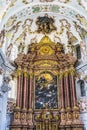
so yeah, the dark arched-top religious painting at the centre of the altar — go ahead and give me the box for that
[35,72,58,109]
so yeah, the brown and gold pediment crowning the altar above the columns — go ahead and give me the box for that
[15,36,76,69]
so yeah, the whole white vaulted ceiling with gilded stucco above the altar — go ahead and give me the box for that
[0,0,87,60]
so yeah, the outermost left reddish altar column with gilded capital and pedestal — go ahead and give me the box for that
[11,67,22,130]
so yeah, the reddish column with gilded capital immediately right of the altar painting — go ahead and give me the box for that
[59,71,66,130]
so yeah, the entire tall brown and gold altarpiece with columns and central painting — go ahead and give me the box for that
[11,36,83,130]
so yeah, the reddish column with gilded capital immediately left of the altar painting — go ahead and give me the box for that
[27,69,34,130]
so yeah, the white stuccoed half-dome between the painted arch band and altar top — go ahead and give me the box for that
[5,14,85,57]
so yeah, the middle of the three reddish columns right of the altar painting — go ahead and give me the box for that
[64,69,72,127]
